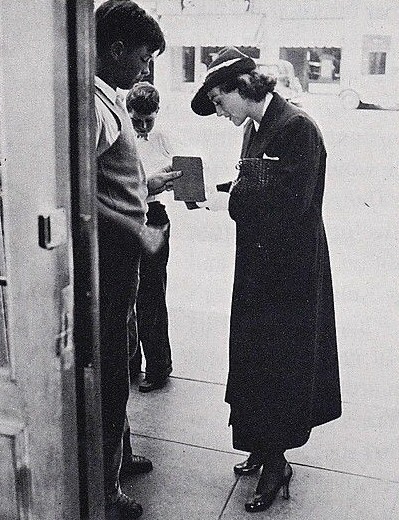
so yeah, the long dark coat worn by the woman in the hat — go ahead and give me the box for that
[226,93,341,451]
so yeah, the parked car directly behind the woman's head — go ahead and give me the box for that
[258,60,303,106]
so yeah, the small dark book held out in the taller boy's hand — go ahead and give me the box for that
[172,155,206,202]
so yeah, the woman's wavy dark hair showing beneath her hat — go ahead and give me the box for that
[218,70,277,101]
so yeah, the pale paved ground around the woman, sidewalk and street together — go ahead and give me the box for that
[126,93,399,520]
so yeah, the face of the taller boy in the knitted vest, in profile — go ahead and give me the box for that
[115,45,156,90]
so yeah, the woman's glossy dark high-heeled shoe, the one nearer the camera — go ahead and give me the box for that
[245,456,293,513]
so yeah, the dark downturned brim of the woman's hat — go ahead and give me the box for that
[191,58,256,116]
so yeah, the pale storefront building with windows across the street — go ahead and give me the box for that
[135,0,399,106]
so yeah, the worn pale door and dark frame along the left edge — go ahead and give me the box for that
[0,0,104,520]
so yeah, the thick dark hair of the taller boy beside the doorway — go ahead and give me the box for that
[96,0,165,55]
